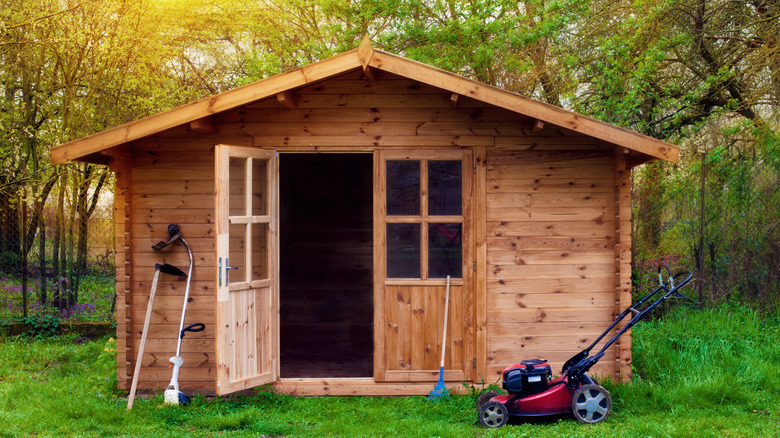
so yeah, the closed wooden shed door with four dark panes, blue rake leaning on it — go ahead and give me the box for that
[374,149,475,382]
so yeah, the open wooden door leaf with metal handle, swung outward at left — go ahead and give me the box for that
[215,145,279,395]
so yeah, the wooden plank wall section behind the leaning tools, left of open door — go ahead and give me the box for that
[120,138,251,393]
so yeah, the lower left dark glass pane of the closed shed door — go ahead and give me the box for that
[387,224,420,278]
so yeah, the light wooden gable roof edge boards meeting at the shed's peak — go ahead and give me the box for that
[51,37,679,164]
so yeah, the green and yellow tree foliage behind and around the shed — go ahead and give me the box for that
[0,0,780,314]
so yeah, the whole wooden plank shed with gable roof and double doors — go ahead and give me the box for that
[51,40,678,395]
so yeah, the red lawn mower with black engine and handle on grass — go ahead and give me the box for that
[477,268,693,427]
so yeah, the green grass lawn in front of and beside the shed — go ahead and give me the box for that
[0,308,780,437]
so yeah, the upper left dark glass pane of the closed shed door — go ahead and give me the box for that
[387,161,420,216]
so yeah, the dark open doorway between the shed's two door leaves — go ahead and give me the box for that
[279,154,374,378]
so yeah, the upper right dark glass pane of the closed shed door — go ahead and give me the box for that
[428,161,463,216]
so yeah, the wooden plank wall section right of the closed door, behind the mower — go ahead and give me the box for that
[485,145,630,382]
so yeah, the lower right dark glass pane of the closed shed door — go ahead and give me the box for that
[428,224,463,278]
